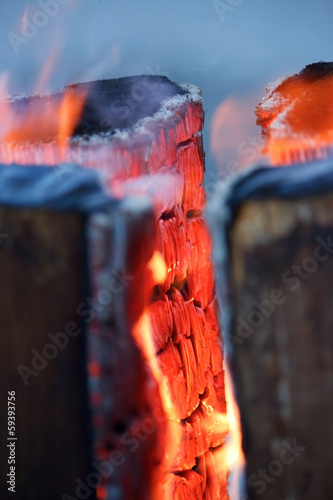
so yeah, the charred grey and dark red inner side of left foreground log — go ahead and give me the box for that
[87,198,164,499]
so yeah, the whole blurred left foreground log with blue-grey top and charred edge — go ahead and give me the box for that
[0,166,162,499]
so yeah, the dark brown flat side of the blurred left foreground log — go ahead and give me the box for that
[0,207,93,500]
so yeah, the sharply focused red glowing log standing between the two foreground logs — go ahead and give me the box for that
[0,76,227,500]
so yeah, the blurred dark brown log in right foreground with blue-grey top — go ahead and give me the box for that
[211,161,333,500]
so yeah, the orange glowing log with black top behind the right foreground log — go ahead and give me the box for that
[256,62,333,165]
